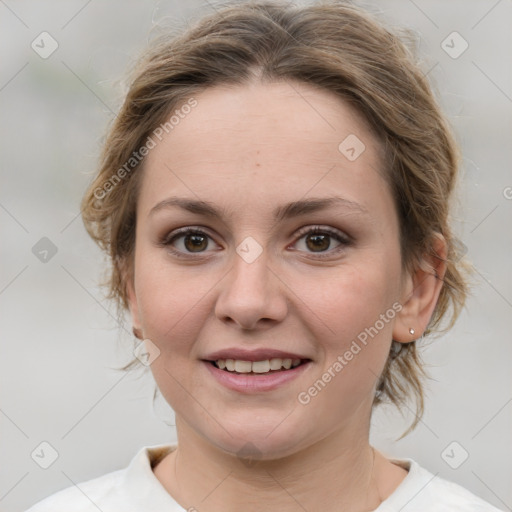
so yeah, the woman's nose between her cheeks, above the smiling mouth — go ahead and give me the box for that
[215,251,288,330]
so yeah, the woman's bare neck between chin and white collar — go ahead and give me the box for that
[155,418,388,512]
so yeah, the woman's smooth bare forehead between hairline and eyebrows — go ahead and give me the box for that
[140,82,383,218]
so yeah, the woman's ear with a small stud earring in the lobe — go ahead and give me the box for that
[393,233,447,343]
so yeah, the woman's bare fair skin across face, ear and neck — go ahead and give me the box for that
[127,82,445,512]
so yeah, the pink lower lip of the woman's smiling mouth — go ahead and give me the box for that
[203,361,311,393]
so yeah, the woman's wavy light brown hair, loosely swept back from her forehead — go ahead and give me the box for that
[82,1,466,431]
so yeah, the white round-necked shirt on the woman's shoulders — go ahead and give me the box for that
[27,445,500,512]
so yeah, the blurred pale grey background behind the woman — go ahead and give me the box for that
[0,0,512,511]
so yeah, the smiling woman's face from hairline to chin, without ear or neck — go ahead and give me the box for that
[129,82,412,459]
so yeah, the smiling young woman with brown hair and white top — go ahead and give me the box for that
[26,2,497,512]
